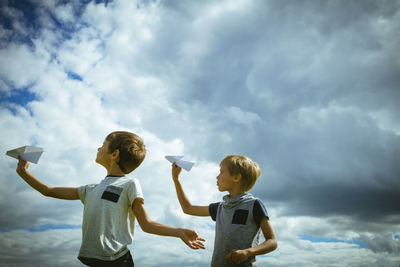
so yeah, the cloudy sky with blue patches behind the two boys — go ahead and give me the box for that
[0,0,400,267]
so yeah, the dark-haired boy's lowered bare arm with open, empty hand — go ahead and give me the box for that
[132,198,205,249]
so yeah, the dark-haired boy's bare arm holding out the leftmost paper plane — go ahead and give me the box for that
[16,157,79,200]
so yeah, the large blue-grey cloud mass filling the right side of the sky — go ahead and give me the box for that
[136,1,400,224]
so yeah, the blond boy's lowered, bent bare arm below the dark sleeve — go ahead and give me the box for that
[226,217,278,264]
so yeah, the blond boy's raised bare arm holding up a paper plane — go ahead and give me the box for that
[172,163,210,216]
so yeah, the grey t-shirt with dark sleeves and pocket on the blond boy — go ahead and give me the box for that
[209,193,268,267]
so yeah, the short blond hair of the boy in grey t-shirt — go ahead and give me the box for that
[220,155,261,192]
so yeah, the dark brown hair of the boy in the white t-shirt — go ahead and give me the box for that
[106,131,146,174]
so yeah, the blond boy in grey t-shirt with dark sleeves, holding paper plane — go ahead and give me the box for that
[172,155,278,267]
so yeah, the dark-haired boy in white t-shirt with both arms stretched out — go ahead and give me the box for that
[17,131,204,267]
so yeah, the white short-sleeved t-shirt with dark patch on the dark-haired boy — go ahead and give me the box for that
[78,176,143,261]
